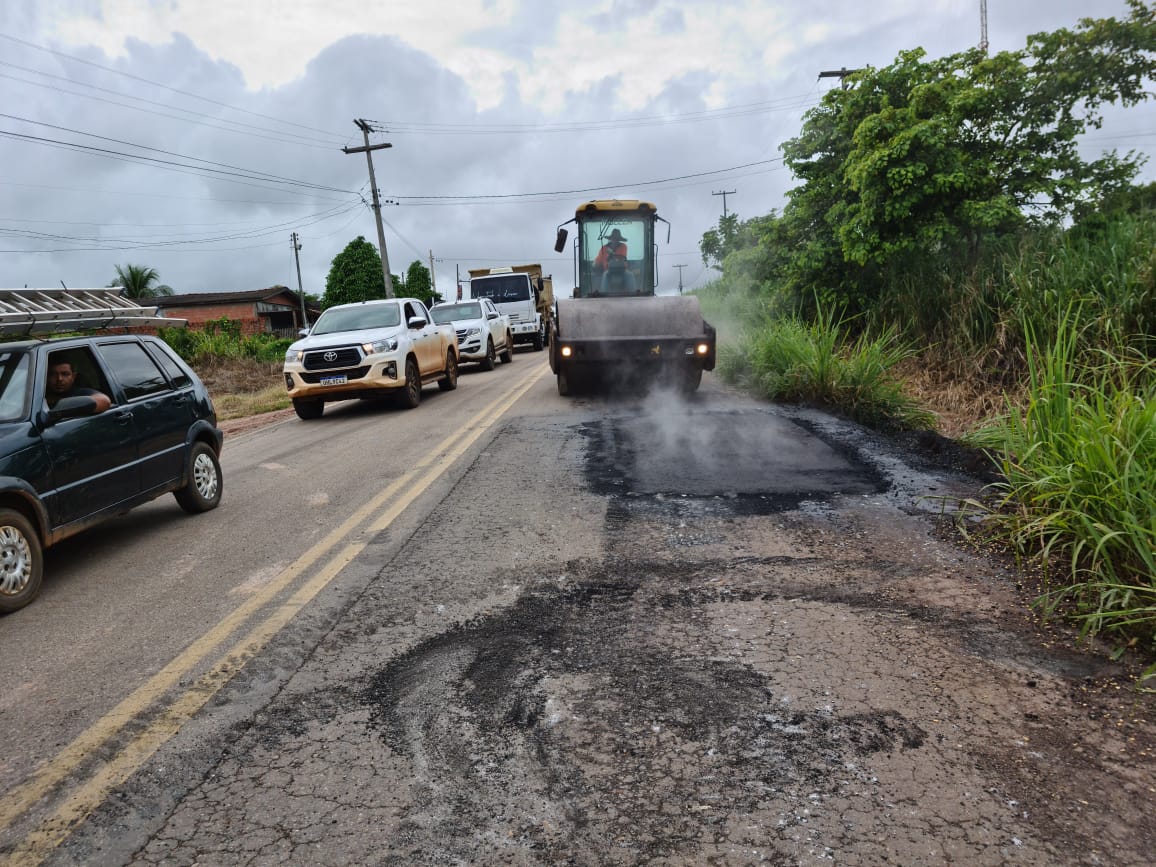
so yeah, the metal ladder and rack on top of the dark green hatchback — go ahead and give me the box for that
[0,289,188,336]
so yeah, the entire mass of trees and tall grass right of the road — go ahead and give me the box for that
[699,0,1156,676]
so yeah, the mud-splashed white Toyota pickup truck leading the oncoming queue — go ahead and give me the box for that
[284,298,458,418]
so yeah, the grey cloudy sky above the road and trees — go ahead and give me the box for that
[0,0,1156,295]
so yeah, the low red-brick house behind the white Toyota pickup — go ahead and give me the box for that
[151,286,321,338]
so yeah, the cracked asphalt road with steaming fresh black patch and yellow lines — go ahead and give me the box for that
[0,351,1156,865]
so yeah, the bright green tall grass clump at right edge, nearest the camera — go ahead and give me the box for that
[973,316,1156,673]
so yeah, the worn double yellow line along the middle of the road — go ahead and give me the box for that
[0,365,549,867]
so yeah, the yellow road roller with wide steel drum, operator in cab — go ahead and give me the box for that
[549,199,716,395]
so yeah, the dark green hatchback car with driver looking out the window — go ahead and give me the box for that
[0,334,223,613]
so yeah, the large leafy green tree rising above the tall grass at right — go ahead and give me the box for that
[784,0,1156,309]
